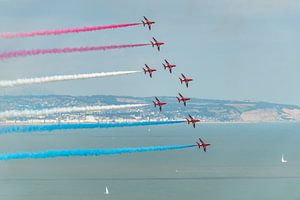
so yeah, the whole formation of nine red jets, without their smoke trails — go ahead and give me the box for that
[142,16,210,152]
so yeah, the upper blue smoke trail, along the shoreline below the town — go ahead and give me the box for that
[0,120,184,134]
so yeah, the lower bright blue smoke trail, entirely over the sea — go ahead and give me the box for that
[0,145,197,160]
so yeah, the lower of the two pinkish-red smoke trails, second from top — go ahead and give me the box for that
[0,44,150,59]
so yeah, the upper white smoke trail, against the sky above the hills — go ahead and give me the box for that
[0,71,140,87]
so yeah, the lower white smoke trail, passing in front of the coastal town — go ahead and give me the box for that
[0,104,148,119]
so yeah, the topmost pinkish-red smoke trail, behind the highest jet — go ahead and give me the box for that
[0,23,141,38]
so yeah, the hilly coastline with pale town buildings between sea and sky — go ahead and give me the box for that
[0,95,300,125]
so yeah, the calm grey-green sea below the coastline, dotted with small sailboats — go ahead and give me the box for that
[0,123,300,200]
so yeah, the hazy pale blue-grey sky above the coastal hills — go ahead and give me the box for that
[0,0,300,105]
